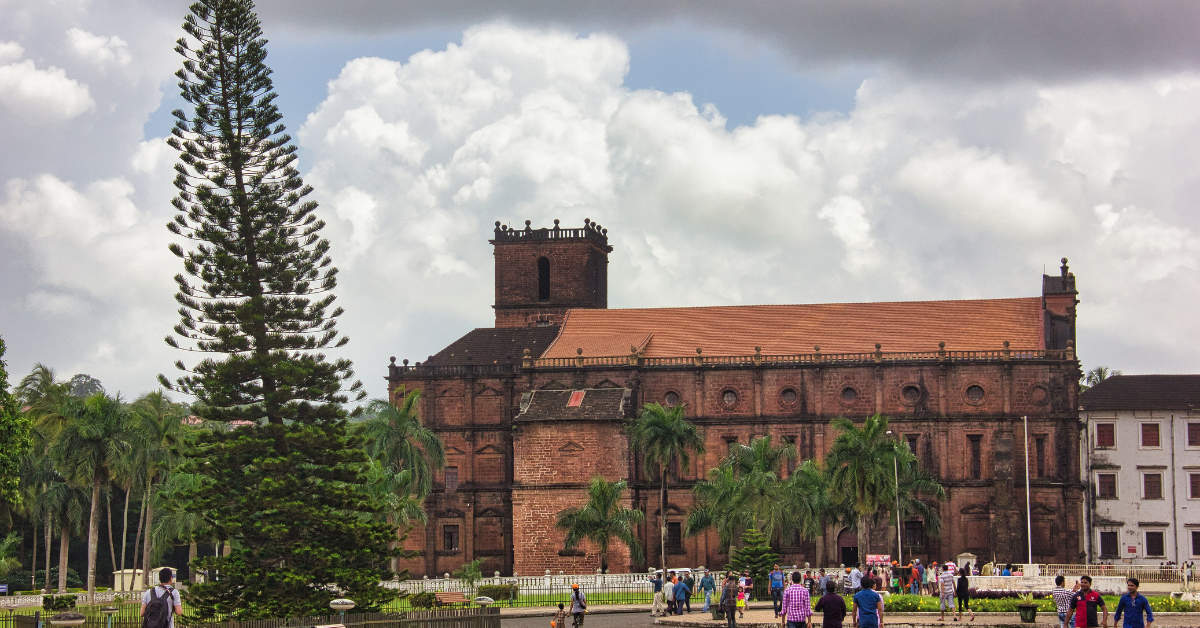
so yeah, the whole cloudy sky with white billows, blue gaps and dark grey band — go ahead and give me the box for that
[0,0,1200,396]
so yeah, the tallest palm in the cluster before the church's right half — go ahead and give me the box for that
[826,414,911,554]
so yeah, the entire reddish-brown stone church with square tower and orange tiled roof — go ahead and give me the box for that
[388,220,1084,578]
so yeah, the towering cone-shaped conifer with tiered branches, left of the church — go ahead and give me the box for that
[160,0,395,620]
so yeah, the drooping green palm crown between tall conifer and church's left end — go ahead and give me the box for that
[358,389,446,500]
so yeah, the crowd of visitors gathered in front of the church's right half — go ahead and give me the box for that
[633,560,1154,628]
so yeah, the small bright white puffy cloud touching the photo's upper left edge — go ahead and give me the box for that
[0,59,96,125]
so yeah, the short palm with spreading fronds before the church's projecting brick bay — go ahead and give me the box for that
[554,476,646,570]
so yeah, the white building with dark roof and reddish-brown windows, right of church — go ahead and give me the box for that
[1079,375,1200,564]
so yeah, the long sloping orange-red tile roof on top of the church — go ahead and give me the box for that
[541,297,1044,358]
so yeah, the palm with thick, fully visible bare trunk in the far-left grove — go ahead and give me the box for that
[50,393,130,597]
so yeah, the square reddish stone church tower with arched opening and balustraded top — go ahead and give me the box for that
[491,219,612,327]
